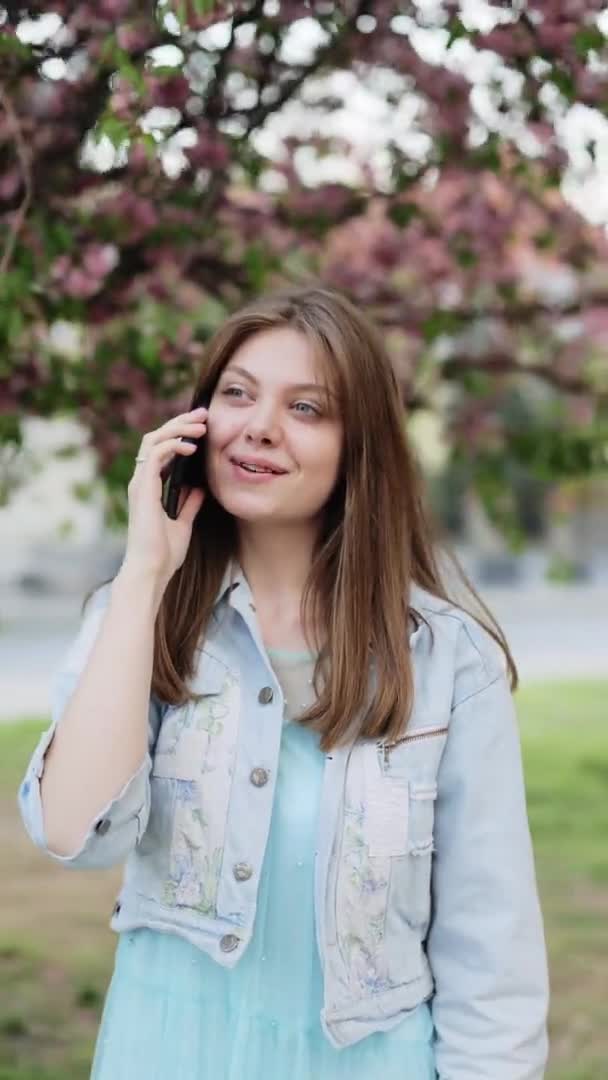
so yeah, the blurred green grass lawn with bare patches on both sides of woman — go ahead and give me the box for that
[0,681,608,1080]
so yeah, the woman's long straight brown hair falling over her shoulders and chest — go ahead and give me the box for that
[92,285,518,752]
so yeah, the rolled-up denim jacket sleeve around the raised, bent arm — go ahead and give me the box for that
[17,584,164,868]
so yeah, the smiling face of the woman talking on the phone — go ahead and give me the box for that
[206,327,342,524]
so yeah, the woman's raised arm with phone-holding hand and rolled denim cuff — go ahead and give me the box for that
[18,409,206,866]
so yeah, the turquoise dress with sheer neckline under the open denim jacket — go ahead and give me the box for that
[91,649,436,1080]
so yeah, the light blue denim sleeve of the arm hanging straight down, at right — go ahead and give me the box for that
[427,632,549,1080]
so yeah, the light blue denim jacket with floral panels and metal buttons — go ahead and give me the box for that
[19,565,549,1080]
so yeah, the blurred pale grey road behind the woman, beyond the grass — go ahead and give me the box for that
[0,581,608,720]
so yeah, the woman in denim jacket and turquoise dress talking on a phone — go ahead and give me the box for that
[19,287,548,1080]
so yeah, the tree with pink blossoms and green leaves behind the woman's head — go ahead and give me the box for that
[0,0,608,529]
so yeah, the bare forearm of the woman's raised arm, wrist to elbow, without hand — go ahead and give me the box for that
[41,567,162,855]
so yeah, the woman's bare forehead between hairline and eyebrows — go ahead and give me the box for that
[225,326,329,387]
